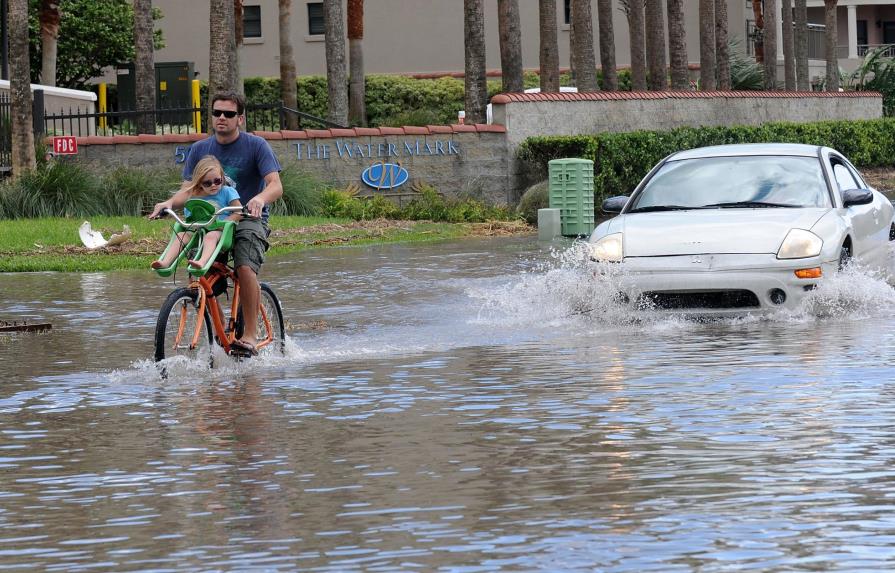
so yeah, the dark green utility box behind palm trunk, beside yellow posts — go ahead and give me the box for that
[118,62,195,123]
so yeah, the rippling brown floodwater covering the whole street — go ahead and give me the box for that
[0,238,895,572]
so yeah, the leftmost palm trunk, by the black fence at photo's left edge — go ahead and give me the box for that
[7,0,37,177]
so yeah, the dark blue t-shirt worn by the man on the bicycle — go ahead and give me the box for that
[183,131,282,221]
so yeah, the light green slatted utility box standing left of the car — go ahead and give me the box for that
[547,158,594,237]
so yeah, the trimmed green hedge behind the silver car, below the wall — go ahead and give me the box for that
[517,118,895,202]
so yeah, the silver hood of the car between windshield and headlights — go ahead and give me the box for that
[610,208,829,257]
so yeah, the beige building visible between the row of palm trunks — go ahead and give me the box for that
[153,0,751,79]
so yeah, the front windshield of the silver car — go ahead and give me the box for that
[630,156,830,211]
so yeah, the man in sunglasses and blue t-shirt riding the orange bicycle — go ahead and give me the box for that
[149,92,283,354]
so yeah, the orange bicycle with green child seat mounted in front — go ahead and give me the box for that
[154,199,286,366]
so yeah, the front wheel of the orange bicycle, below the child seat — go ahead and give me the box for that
[155,288,212,362]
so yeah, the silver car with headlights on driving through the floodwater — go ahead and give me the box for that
[587,144,895,314]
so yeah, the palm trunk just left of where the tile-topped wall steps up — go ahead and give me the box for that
[463,0,488,123]
